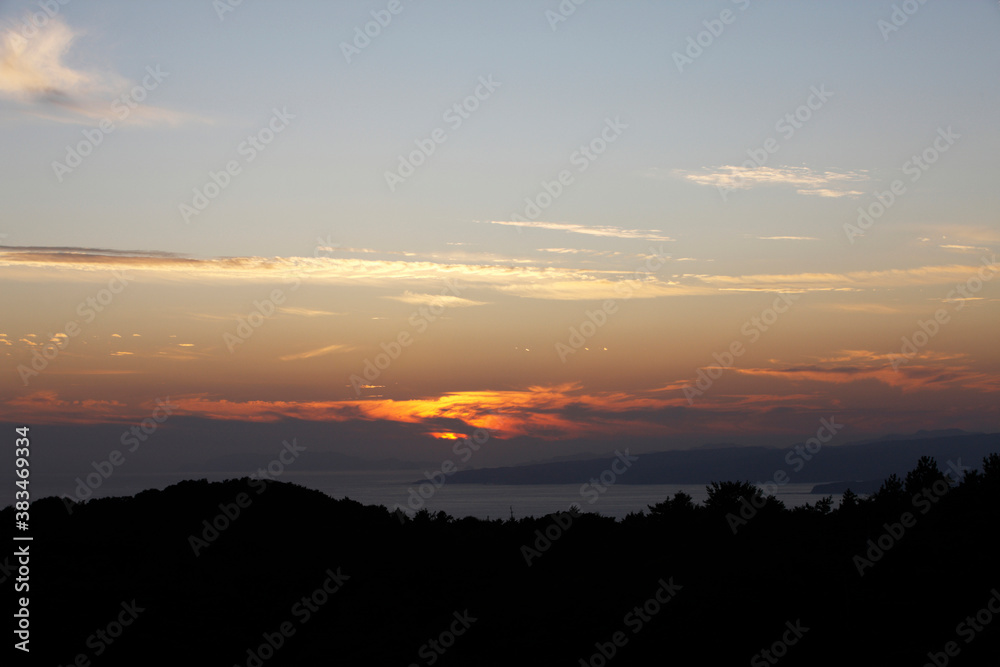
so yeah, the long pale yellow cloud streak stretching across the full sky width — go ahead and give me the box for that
[0,249,996,302]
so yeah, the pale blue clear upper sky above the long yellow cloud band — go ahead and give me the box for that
[0,2,1000,265]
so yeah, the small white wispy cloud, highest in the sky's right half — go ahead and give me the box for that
[672,165,868,197]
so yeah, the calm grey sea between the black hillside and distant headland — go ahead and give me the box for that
[29,470,840,519]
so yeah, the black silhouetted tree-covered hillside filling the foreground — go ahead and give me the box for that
[7,454,1000,667]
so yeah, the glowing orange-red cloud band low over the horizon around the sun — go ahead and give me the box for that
[5,358,1000,430]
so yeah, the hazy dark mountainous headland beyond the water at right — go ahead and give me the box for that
[449,433,1000,484]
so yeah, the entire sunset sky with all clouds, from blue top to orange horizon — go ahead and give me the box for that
[0,0,1000,465]
